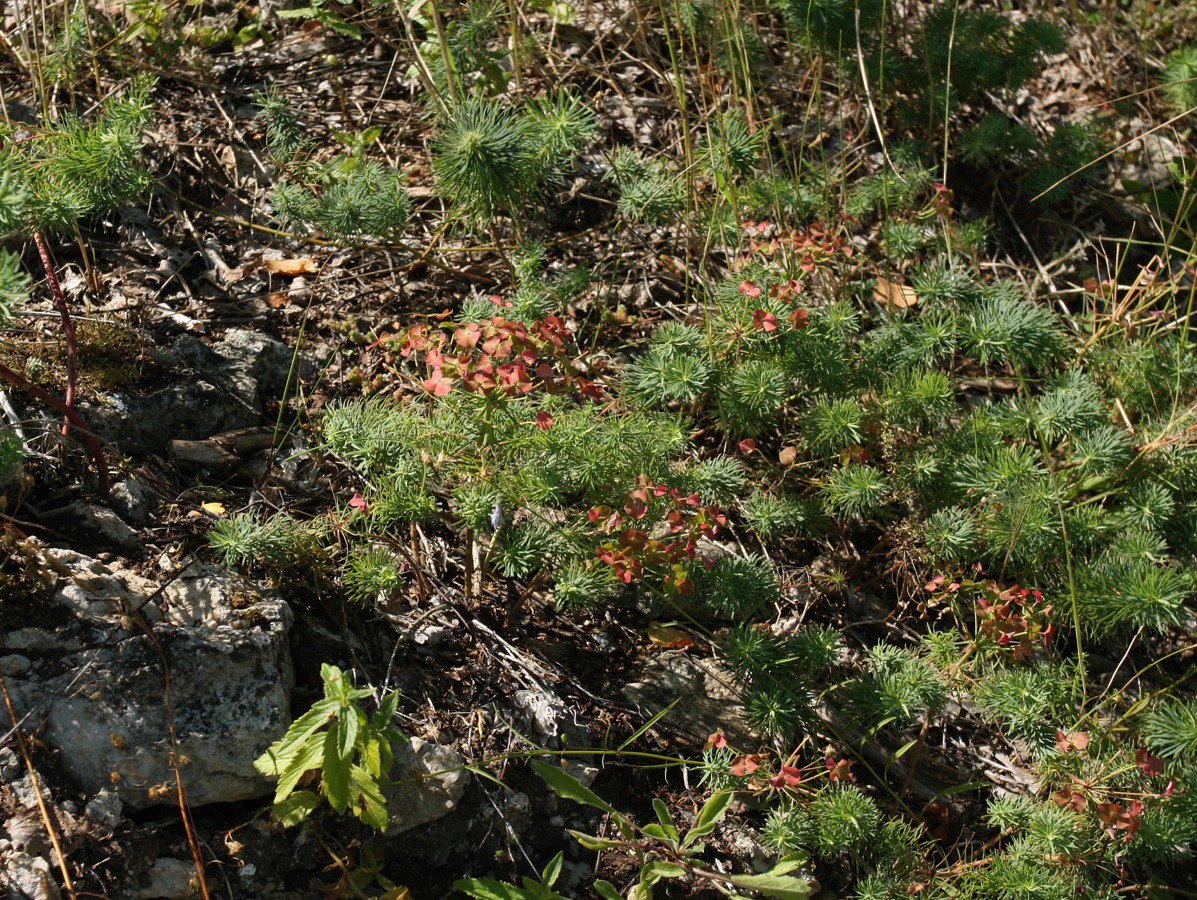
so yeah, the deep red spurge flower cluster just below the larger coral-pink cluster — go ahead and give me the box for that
[589,475,728,594]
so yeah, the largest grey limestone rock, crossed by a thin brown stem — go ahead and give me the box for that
[10,551,293,809]
